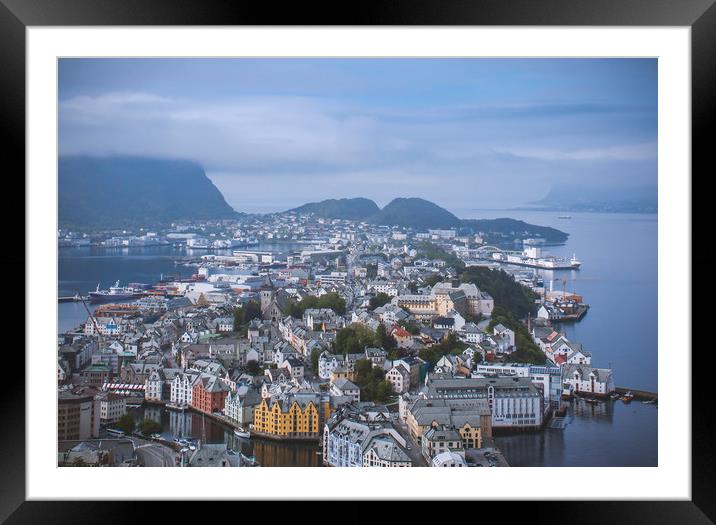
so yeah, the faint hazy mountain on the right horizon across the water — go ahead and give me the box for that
[530,184,659,213]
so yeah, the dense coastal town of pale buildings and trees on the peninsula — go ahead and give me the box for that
[57,213,634,467]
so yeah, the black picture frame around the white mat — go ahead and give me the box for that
[0,0,716,524]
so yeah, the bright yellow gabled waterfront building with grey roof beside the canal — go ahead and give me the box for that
[251,392,326,440]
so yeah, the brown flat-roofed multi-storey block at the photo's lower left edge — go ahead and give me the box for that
[57,389,100,441]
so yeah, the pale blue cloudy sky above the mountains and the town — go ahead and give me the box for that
[59,58,657,212]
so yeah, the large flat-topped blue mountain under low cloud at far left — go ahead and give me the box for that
[58,156,239,228]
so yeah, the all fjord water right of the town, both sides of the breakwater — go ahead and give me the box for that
[457,210,656,467]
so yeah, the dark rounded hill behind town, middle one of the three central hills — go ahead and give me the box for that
[368,197,462,228]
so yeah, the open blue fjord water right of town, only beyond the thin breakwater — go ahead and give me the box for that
[457,210,656,392]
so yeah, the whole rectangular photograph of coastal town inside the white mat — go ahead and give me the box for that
[56,56,660,466]
